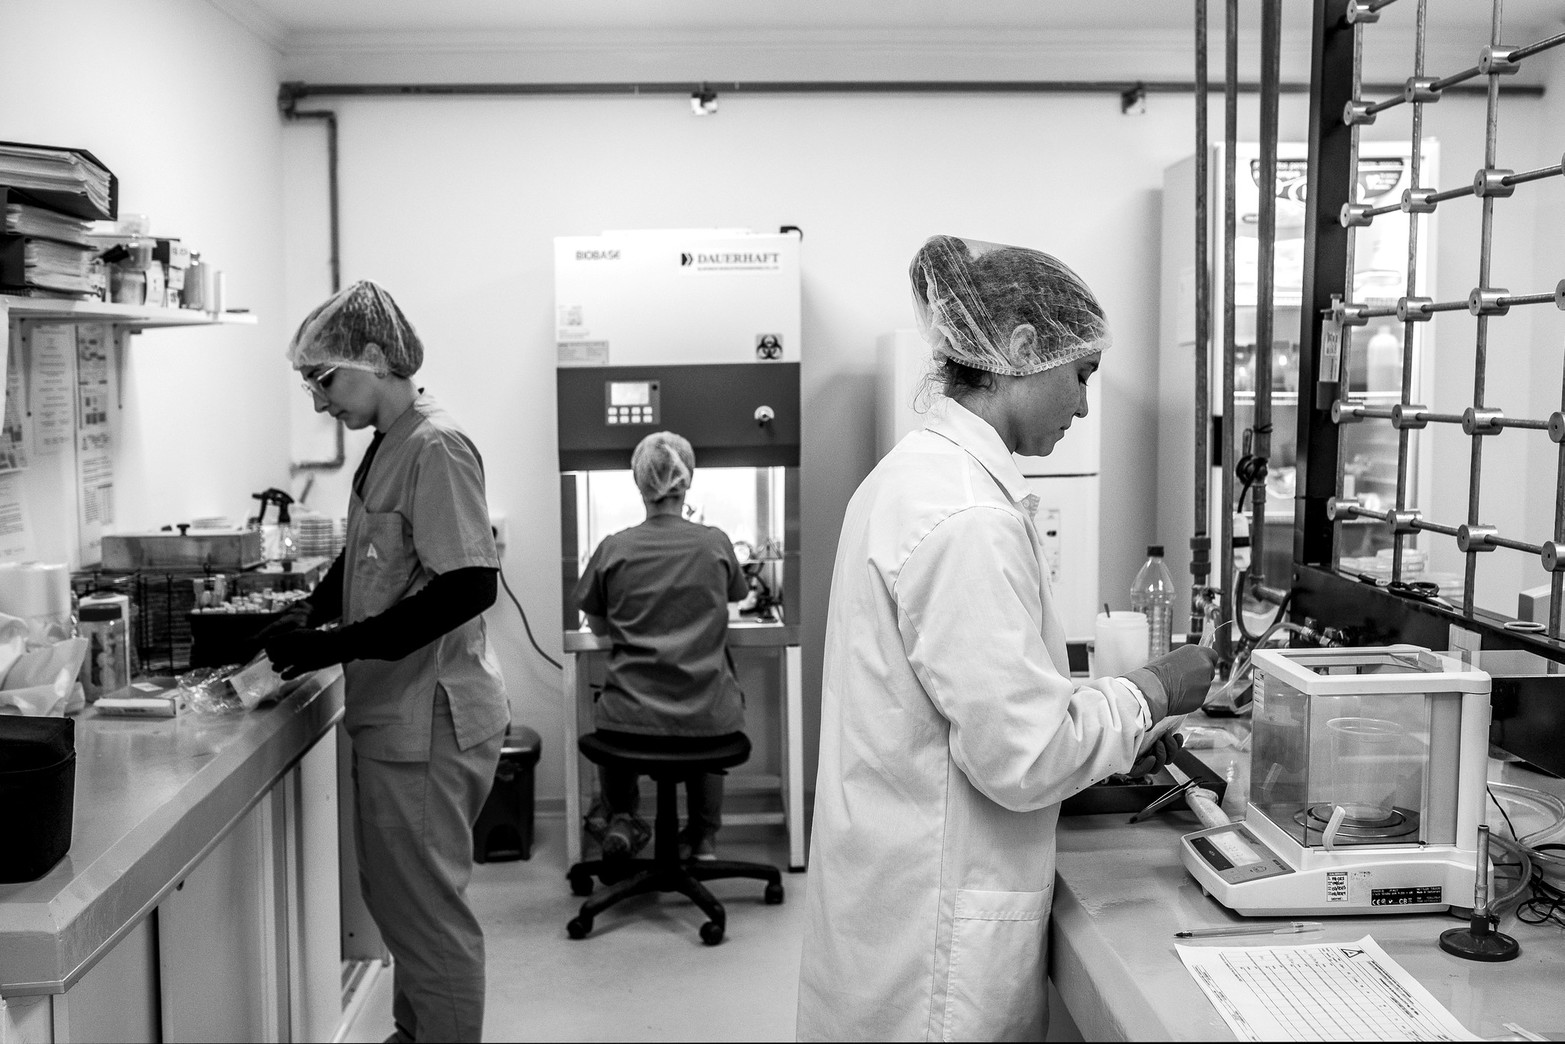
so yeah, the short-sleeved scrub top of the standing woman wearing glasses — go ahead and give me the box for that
[343,393,510,761]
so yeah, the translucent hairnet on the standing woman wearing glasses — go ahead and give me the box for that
[288,279,424,377]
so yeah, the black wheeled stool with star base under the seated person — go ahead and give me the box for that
[565,733,783,945]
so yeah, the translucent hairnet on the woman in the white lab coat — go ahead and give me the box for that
[908,236,1110,377]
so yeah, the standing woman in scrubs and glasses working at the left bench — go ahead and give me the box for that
[266,282,510,1041]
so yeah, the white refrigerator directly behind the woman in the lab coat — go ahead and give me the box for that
[875,330,1101,639]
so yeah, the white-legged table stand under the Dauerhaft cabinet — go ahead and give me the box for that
[562,620,804,870]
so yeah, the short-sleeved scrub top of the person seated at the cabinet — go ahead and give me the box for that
[576,515,750,736]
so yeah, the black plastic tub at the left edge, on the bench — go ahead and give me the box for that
[0,715,77,884]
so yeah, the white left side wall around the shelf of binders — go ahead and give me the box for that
[0,0,290,540]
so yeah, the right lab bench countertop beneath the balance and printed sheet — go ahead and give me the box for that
[1049,720,1565,1041]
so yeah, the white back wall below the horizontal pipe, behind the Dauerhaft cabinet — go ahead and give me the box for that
[275,94,1191,795]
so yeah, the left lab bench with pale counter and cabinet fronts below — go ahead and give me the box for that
[0,668,353,1042]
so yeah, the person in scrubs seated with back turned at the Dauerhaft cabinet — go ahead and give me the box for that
[576,432,748,859]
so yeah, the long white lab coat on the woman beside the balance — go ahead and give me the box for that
[798,402,1150,1041]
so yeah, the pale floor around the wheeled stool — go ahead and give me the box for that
[344,819,804,1041]
